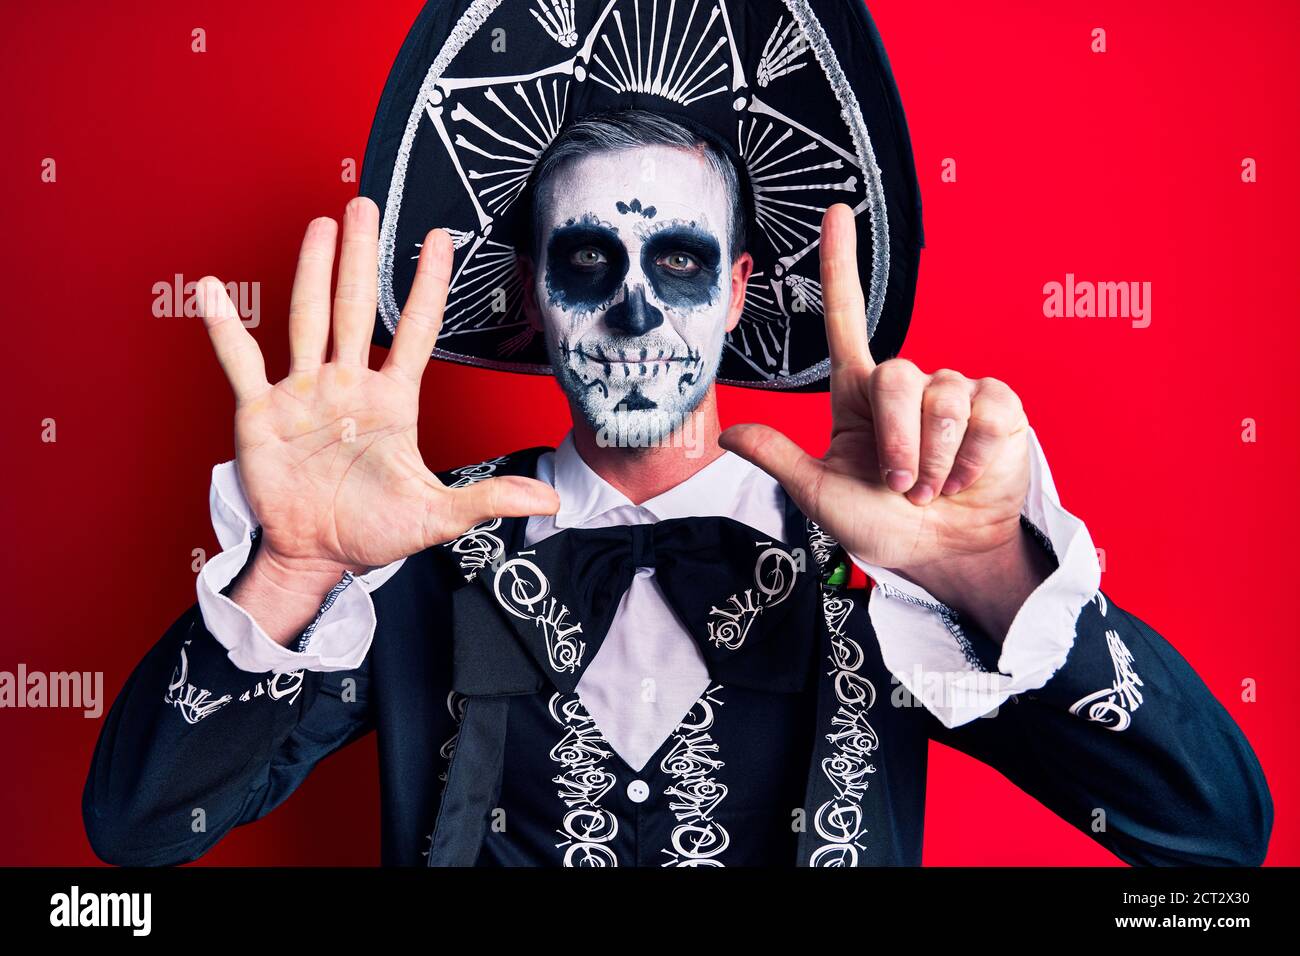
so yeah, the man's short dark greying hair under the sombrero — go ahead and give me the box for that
[528,108,753,261]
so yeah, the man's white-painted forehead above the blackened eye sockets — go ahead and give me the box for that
[537,146,729,234]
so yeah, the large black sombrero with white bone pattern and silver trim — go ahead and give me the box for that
[361,0,924,392]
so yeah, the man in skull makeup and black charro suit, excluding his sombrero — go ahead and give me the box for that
[85,0,1273,865]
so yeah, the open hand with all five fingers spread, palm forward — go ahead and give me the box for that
[199,198,559,643]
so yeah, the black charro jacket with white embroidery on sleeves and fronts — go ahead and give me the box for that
[83,447,1273,866]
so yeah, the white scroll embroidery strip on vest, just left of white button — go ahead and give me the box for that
[550,693,619,866]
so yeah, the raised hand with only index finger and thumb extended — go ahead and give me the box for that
[720,204,1043,634]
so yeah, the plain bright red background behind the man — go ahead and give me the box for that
[0,0,1300,865]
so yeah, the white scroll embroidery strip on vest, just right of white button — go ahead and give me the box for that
[659,684,731,866]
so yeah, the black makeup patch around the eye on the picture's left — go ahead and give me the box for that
[546,216,628,312]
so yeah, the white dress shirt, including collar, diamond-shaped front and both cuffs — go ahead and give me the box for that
[198,429,1101,769]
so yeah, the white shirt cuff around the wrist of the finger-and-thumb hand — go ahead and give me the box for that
[849,428,1101,727]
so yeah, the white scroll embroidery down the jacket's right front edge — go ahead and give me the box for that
[807,520,880,866]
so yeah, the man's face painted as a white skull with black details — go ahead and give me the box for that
[534,146,732,434]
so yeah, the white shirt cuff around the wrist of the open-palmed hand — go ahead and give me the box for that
[196,460,406,674]
